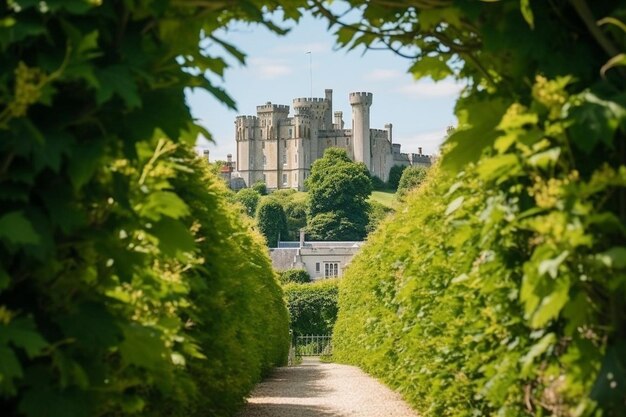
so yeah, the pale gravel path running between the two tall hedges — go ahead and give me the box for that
[238,358,417,417]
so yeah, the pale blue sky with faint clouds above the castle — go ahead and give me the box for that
[187,9,460,160]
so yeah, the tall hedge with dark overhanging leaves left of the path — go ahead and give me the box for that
[0,1,289,417]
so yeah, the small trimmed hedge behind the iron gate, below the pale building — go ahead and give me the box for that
[283,279,339,335]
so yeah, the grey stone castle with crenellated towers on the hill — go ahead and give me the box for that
[235,89,431,190]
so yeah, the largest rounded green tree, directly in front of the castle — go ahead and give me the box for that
[306,148,372,240]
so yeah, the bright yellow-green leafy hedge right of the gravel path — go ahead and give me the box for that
[333,158,626,417]
